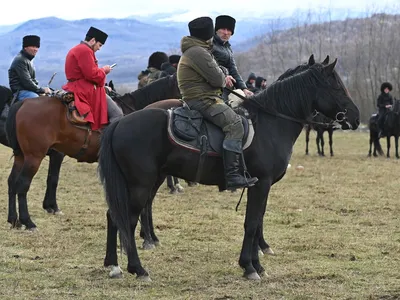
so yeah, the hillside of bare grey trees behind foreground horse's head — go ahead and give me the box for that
[233,12,400,122]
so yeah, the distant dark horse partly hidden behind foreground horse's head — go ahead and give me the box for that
[305,112,336,156]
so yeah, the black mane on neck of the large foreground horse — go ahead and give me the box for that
[244,63,322,118]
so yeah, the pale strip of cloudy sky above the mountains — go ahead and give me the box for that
[0,0,400,25]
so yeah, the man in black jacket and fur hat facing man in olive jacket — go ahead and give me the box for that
[212,15,253,101]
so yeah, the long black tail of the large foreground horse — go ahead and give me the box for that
[98,122,134,253]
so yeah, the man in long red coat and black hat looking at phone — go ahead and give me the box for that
[62,27,122,130]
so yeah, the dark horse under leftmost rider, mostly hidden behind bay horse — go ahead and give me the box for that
[0,86,64,214]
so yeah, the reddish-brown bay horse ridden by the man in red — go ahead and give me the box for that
[5,76,180,230]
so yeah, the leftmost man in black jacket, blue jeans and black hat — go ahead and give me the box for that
[8,35,50,100]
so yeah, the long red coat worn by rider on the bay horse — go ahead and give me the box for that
[62,42,108,130]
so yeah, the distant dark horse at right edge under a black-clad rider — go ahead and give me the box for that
[368,99,400,159]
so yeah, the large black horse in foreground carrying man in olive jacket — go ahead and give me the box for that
[99,60,360,279]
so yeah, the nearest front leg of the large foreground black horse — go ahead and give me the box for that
[239,180,271,280]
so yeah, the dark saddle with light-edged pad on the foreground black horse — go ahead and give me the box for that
[168,105,254,156]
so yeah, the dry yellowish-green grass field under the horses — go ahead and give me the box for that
[0,132,400,300]
